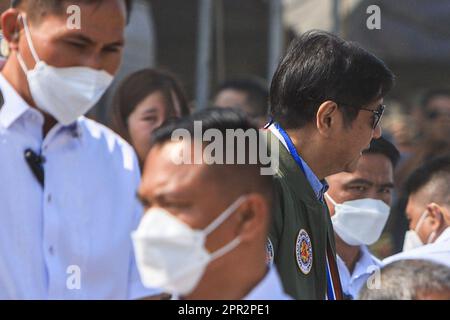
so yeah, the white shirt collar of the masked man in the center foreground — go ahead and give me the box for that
[243,266,292,300]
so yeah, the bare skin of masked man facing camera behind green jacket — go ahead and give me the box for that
[327,154,394,272]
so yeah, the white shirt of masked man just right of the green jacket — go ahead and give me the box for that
[336,245,383,299]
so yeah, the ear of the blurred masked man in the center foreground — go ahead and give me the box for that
[237,193,270,243]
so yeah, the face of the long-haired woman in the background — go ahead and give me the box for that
[127,91,181,163]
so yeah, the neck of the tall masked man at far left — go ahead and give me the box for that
[2,52,57,137]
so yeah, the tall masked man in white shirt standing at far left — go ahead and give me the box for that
[0,0,159,299]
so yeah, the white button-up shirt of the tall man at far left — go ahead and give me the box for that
[0,74,156,299]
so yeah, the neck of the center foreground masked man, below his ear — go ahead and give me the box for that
[183,248,267,300]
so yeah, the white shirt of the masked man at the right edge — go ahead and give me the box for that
[383,227,450,267]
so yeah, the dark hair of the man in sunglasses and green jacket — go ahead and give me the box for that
[270,31,394,129]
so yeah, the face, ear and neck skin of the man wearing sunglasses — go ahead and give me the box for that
[287,99,383,179]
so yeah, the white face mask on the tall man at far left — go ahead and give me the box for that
[17,16,114,125]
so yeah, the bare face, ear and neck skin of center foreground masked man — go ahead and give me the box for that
[138,142,269,299]
